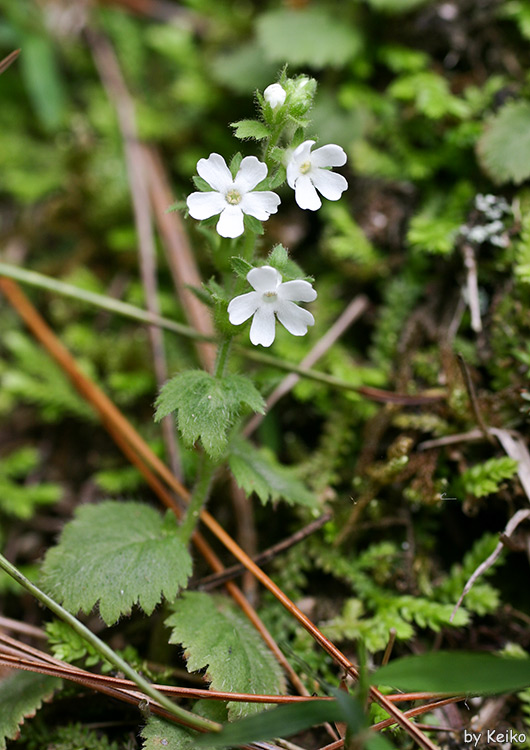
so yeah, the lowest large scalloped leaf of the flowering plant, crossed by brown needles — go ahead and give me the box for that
[166,591,285,719]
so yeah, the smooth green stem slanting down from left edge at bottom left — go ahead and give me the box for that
[0,555,221,732]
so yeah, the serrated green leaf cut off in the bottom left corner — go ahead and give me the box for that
[0,672,62,750]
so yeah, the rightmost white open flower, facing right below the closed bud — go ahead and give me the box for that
[287,141,348,211]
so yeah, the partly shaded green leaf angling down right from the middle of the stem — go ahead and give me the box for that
[228,440,318,508]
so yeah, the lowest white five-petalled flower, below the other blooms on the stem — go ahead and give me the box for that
[228,266,317,346]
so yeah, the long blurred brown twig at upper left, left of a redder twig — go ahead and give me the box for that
[85,28,182,478]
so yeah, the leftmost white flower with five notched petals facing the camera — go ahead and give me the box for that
[186,154,280,237]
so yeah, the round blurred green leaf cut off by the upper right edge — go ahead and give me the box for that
[477,101,530,184]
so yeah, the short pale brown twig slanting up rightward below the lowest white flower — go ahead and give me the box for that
[243,295,369,437]
